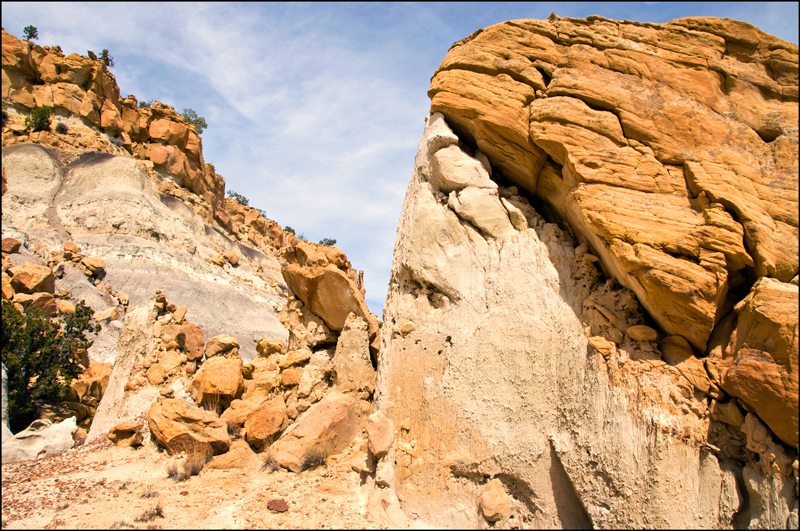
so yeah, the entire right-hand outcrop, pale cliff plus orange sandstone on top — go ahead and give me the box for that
[376,15,798,527]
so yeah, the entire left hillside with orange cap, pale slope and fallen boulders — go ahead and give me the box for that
[2,26,380,477]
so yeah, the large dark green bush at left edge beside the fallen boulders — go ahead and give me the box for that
[0,300,100,433]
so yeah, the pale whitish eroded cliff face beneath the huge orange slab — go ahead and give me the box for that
[376,113,796,528]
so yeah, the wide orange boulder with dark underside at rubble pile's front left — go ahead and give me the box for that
[147,399,231,455]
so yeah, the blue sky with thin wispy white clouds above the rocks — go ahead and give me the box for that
[2,2,798,317]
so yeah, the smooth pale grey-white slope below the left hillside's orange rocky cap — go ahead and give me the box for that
[3,144,288,362]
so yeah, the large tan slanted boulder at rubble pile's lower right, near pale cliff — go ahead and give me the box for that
[271,391,358,472]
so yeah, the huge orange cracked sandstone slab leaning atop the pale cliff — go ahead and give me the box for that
[429,17,798,351]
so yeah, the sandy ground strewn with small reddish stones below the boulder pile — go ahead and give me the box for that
[2,441,382,529]
